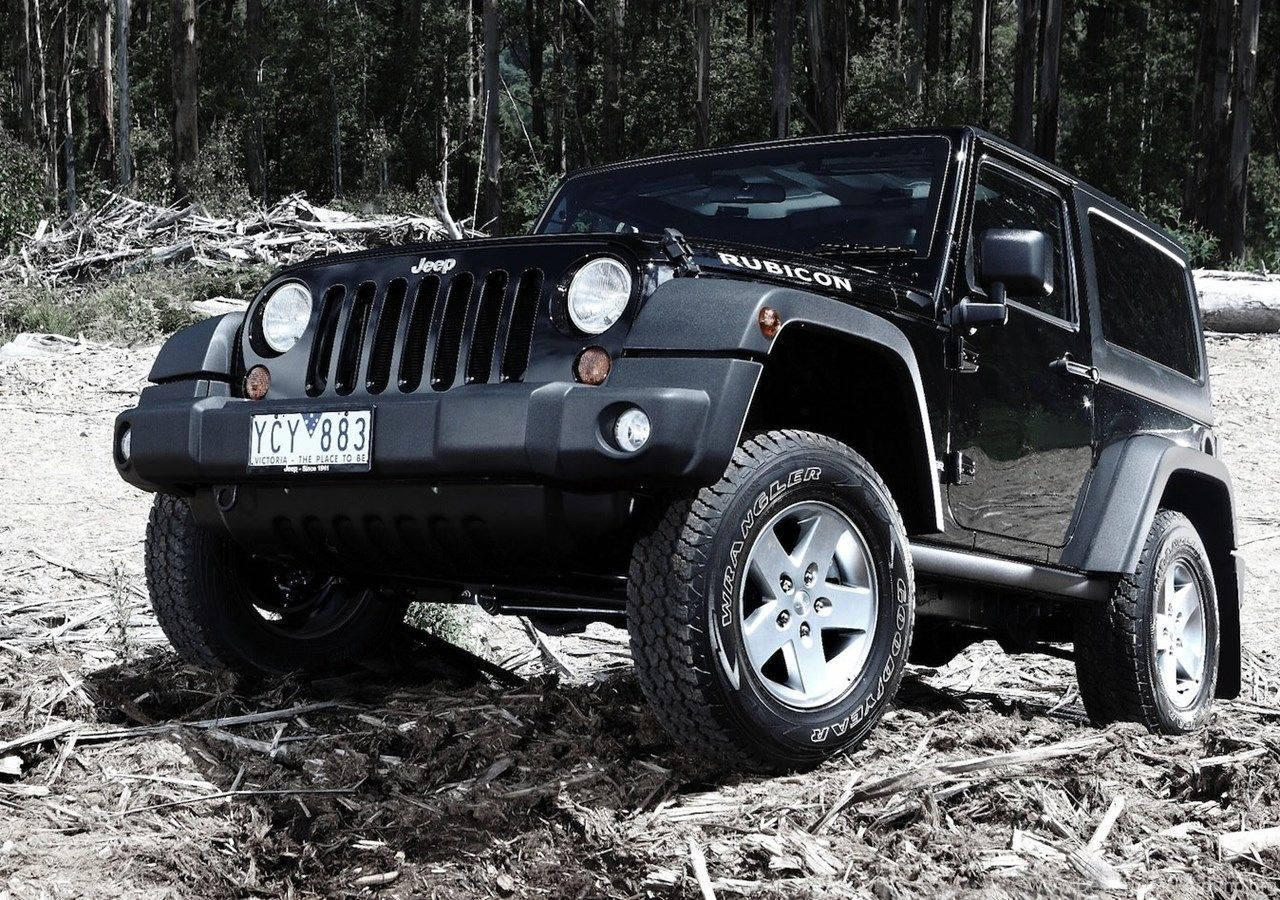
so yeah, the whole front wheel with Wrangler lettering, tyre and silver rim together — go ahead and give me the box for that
[627,431,915,771]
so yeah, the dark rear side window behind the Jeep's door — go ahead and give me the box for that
[1089,214,1199,378]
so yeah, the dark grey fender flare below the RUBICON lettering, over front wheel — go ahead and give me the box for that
[625,278,945,531]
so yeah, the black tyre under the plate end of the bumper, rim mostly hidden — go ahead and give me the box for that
[146,494,404,675]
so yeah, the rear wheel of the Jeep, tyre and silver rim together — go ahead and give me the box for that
[1075,510,1219,734]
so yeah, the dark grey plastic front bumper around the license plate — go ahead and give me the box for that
[115,357,762,493]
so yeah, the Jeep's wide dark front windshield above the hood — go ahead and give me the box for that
[538,137,948,264]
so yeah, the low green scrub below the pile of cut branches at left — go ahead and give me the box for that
[0,265,270,344]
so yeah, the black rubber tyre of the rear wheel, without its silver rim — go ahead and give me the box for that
[1075,510,1220,734]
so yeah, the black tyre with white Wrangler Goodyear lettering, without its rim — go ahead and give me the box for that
[627,430,915,772]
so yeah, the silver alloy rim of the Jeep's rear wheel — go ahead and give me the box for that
[1155,559,1206,709]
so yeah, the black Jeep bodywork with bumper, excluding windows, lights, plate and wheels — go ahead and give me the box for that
[116,128,1239,694]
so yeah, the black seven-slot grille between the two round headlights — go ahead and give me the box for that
[307,269,543,397]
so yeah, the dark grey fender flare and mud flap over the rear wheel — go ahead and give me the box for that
[1060,434,1243,698]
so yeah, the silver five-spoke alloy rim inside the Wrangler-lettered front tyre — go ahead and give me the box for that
[739,501,879,709]
